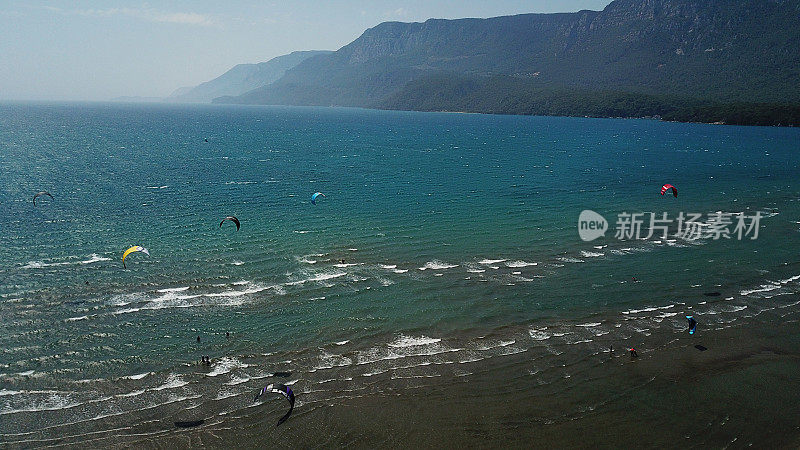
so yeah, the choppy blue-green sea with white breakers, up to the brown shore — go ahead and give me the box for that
[0,104,800,441]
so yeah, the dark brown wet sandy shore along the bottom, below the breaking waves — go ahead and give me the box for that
[31,314,800,448]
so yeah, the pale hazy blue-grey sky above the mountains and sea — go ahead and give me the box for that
[0,0,610,100]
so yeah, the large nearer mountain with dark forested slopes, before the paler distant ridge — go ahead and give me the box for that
[206,0,800,125]
